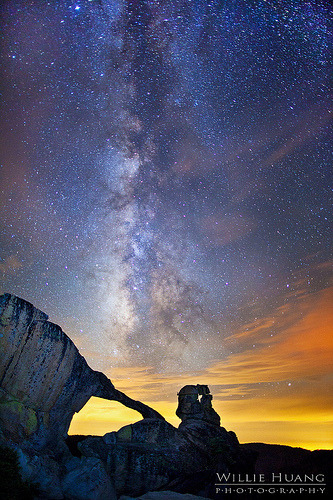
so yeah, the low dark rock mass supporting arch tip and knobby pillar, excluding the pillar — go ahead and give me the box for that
[78,419,239,498]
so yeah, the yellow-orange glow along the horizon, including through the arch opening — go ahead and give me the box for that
[70,288,333,450]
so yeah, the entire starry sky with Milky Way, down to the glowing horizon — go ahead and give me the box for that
[0,0,333,449]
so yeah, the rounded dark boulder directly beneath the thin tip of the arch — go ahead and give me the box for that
[78,419,184,495]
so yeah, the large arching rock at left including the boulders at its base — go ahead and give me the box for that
[0,294,164,500]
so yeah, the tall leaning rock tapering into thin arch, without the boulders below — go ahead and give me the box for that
[0,294,163,450]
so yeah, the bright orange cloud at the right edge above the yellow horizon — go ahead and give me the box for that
[208,288,333,383]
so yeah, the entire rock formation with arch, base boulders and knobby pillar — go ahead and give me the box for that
[0,294,249,500]
